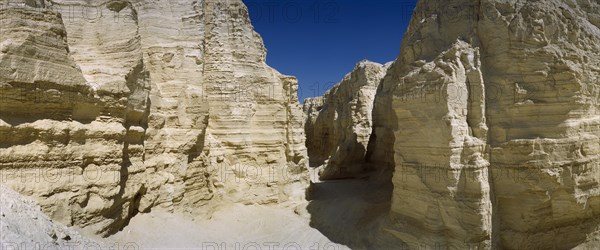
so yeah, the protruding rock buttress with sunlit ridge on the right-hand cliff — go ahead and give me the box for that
[384,42,492,247]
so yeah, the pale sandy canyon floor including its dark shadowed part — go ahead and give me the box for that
[96,168,391,250]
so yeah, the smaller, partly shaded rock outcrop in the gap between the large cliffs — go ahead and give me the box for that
[303,61,389,179]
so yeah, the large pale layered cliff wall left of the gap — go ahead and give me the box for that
[0,0,306,234]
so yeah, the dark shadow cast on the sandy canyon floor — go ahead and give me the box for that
[307,165,393,249]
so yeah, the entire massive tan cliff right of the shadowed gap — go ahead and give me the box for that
[372,0,600,249]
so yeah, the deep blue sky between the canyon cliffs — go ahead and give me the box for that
[243,0,416,102]
